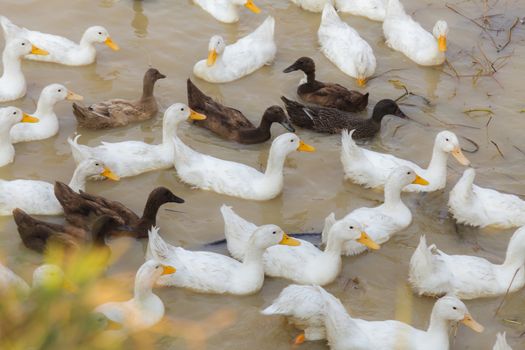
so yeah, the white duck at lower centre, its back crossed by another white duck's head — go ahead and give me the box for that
[221,205,379,285]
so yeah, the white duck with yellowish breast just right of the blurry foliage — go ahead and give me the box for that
[95,260,176,332]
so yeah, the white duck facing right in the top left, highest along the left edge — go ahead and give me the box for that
[0,16,120,66]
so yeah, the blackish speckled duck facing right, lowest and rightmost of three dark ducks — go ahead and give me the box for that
[281,96,407,139]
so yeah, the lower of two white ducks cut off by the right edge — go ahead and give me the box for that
[408,231,525,299]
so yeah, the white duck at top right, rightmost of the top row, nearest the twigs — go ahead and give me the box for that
[383,0,448,66]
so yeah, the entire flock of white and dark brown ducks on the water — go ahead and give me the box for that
[0,0,525,350]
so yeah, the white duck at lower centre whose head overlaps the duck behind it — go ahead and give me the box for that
[147,225,300,295]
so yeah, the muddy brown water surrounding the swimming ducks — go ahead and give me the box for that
[0,0,525,350]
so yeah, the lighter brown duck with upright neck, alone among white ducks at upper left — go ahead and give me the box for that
[73,68,166,130]
